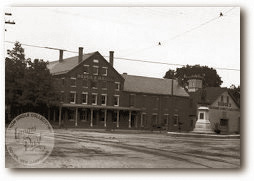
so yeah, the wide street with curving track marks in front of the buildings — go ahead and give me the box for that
[6,130,240,168]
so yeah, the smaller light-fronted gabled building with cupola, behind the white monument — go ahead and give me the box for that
[189,76,240,134]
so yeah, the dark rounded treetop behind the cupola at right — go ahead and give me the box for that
[164,65,223,87]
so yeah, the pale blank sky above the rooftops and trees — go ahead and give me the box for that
[5,7,240,87]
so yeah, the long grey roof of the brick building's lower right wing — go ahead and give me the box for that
[122,74,189,97]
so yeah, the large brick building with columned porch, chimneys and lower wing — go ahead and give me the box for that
[48,47,192,131]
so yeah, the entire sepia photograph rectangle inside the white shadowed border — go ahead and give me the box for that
[3,6,241,169]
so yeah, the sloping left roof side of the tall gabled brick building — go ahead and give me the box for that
[48,52,96,75]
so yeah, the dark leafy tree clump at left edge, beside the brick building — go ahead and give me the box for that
[5,42,59,119]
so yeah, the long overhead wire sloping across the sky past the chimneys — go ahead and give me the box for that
[5,41,240,71]
